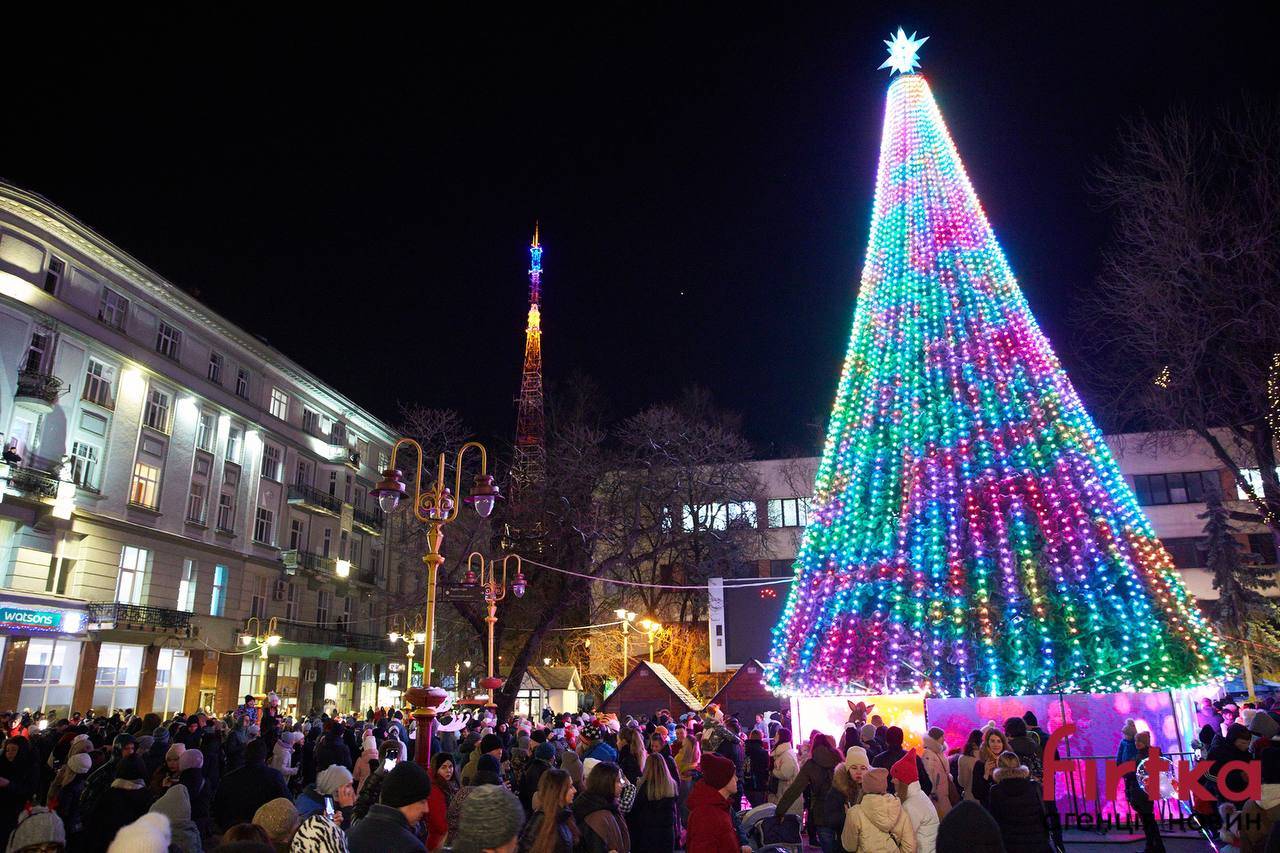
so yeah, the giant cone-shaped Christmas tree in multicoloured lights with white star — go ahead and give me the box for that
[769,29,1224,695]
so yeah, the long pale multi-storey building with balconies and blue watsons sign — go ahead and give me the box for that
[0,183,404,715]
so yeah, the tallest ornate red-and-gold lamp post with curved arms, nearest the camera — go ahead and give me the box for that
[370,438,499,772]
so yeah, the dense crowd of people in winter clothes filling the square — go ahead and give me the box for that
[0,697,1280,853]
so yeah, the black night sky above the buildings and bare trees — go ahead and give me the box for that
[0,3,1276,455]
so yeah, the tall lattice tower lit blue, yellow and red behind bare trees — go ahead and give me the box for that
[511,224,547,508]
